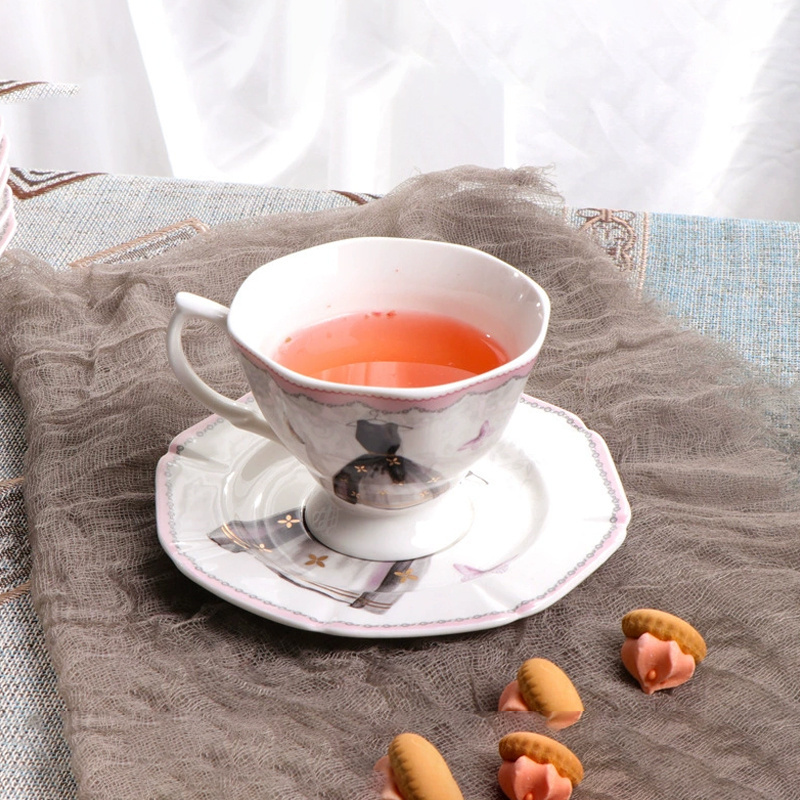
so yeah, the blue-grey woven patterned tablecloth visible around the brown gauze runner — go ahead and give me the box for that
[0,167,800,800]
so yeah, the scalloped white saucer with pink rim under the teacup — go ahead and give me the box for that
[156,395,630,638]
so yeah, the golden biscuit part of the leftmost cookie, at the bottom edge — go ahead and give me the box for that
[389,733,464,800]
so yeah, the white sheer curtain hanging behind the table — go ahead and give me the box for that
[0,0,800,220]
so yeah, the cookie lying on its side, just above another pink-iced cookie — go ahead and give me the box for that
[497,658,583,731]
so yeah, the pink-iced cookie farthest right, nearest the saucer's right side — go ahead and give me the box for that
[620,608,706,694]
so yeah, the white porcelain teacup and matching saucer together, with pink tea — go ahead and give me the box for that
[156,237,630,637]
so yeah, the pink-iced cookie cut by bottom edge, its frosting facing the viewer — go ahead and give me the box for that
[497,731,583,800]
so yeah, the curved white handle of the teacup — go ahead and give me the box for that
[167,292,279,442]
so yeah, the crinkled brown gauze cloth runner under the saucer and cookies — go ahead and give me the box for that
[0,168,800,800]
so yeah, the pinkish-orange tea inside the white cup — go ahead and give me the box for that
[274,309,509,388]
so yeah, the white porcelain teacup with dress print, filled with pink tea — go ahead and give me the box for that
[167,238,550,561]
